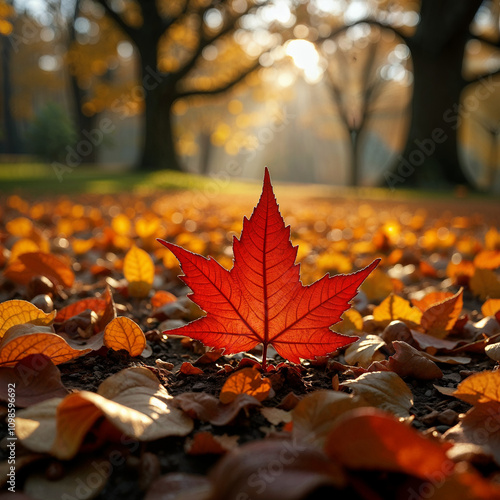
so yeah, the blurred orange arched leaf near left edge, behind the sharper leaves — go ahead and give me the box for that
[4,252,75,288]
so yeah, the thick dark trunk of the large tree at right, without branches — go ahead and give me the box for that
[389,0,481,187]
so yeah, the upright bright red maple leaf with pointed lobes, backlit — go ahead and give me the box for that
[158,168,380,369]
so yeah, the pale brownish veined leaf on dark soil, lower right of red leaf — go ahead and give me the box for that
[342,372,413,418]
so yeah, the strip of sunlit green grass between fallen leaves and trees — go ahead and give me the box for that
[0,163,497,202]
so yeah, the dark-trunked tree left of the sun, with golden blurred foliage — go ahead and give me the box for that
[85,0,284,170]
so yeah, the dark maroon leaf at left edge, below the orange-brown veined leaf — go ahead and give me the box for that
[0,354,68,408]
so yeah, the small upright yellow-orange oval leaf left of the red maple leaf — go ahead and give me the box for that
[123,245,155,298]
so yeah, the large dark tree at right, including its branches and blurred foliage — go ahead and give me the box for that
[312,0,499,187]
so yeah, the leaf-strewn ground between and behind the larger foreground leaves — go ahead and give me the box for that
[0,180,500,499]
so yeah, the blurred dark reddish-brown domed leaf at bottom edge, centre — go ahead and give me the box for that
[209,439,346,500]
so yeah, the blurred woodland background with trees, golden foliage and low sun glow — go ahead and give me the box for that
[0,0,500,193]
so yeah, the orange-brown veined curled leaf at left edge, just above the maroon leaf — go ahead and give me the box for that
[0,323,91,366]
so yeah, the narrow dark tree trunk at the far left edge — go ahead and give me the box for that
[0,36,20,154]
